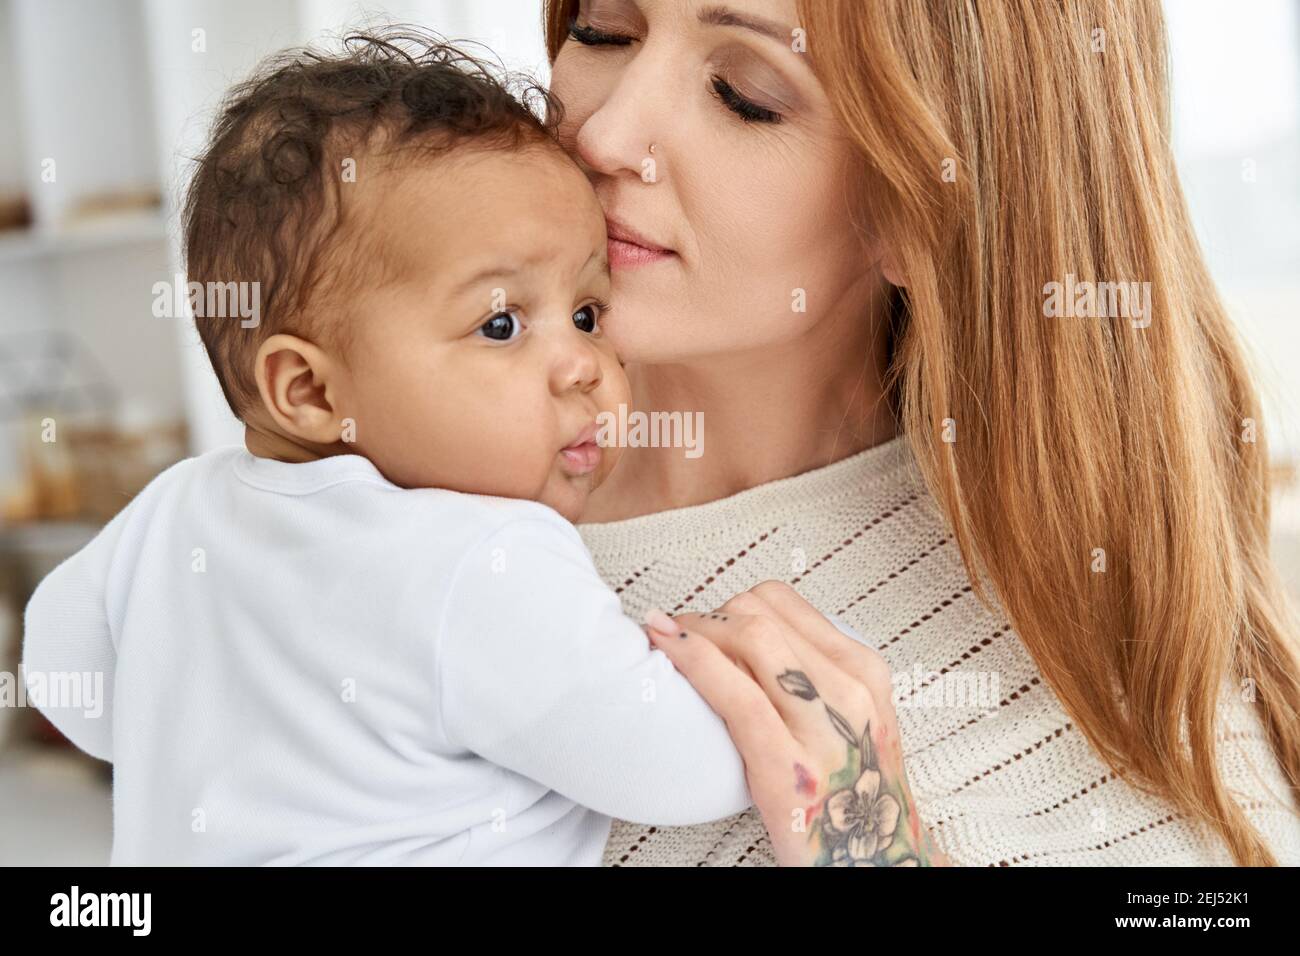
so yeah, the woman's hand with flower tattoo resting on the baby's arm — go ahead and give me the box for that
[646,581,950,866]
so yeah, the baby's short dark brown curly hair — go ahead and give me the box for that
[182,27,560,419]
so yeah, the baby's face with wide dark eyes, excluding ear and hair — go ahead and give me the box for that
[341,150,628,520]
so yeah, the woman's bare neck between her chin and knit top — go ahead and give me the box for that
[580,303,897,523]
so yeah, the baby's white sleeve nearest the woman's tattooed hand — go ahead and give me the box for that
[434,515,751,826]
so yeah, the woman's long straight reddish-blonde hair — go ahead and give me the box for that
[546,0,1300,865]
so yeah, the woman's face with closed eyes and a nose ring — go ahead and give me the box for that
[551,0,880,363]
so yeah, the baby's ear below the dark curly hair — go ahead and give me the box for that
[255,333,342,445]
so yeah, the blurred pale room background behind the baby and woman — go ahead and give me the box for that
[0,0,1300,865]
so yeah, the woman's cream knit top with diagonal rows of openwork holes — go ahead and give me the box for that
[579,438,1300,866]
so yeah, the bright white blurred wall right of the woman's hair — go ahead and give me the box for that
[1165,0,1300,460]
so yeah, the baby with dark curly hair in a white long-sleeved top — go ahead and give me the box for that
[25,31,750,865]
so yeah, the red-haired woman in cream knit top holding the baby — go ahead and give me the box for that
[546,0,1300,865]
